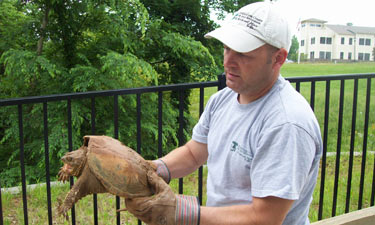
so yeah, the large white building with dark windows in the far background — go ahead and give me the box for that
[299,19,375,61]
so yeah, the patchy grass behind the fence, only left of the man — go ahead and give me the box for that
[1,170,207,225]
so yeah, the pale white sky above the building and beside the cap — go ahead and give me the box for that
[212,0,375,36]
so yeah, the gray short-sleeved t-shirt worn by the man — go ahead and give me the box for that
[193,76,322,225]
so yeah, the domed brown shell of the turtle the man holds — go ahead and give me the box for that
[84,136,155,198]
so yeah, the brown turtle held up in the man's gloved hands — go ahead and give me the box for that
[57,135,162,218]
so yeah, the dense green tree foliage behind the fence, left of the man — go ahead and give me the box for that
[0,0,256,186]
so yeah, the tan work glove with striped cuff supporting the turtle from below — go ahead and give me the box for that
[125,172,200,225]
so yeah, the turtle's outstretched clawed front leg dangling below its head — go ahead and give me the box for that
[58,165,107,217]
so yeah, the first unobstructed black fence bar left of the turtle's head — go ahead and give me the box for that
[43,102,52,225]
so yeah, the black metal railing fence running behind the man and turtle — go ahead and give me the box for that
[0,74,375,225]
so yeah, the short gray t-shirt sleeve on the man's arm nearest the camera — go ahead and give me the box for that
[250,123,316,200]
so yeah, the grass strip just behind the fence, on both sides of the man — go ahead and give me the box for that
[2,154,374,225]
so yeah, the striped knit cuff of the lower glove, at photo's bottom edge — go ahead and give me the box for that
[176,195,200,225]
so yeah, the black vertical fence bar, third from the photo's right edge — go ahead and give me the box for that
[332,80,345,217]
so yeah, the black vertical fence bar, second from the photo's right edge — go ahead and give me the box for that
[345,79,358,213]
